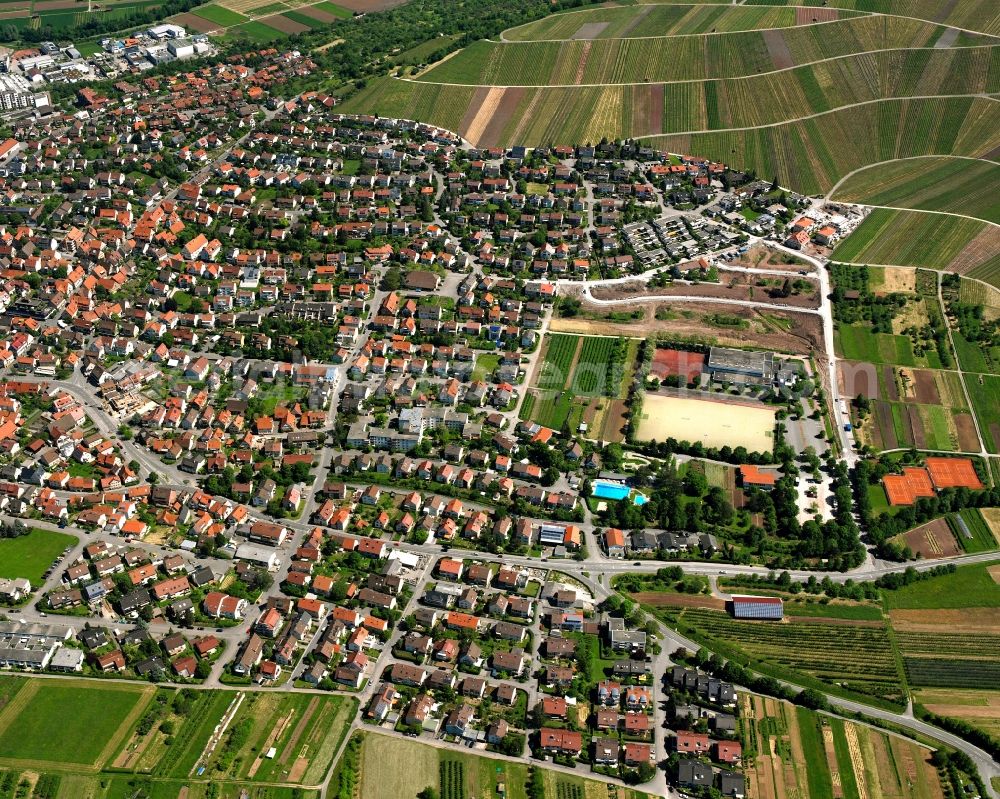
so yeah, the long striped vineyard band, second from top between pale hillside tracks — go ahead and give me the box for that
[420,16,960,85]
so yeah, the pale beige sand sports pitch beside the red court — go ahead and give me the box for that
[636,393,775,452]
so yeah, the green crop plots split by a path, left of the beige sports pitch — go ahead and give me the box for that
[521,333,639,441]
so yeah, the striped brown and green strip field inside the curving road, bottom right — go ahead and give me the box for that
[739,694,942,799]
